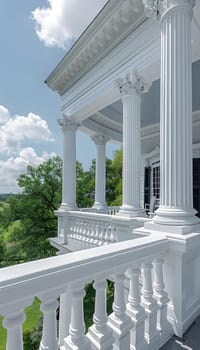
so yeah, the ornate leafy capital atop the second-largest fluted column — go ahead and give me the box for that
[115,71,151,97]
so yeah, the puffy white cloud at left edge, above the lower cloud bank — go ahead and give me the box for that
[0,106,52,153]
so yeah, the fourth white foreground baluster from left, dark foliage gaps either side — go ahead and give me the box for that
[87,279,114,350]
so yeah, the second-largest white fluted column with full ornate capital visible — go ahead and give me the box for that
[116,72,149,217]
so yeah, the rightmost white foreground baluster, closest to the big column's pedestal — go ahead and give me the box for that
[153,257,171,335]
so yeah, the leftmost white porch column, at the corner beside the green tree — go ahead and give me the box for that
[58,117,78,211]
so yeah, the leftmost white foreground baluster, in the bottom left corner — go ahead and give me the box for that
[1,298,33,350]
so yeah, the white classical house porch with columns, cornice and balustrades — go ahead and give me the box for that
[0,0,200,350]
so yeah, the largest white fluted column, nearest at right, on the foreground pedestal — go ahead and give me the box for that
[144,0,199,227]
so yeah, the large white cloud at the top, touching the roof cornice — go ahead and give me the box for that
[32,0,107,49]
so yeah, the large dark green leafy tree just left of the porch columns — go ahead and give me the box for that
[10,157,62,260]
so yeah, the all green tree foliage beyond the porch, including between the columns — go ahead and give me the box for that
[0,150,122,265]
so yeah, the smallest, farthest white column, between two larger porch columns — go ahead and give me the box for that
[92,134,108,211]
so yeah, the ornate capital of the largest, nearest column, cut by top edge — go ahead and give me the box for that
[143,0,196,19]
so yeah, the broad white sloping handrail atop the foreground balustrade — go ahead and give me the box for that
[0,235,168,304]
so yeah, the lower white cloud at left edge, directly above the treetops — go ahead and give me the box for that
[0,147,56,193]
